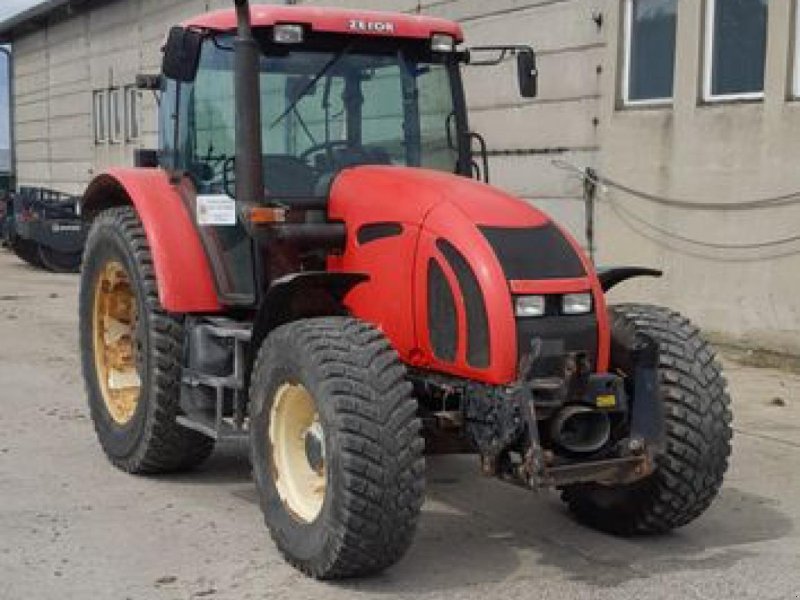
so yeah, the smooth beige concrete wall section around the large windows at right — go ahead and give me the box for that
[598,0,800,352]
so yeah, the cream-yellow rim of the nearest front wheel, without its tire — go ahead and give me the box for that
[269,384,327,523]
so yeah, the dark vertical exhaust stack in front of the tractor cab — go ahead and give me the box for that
[234,0,264,204]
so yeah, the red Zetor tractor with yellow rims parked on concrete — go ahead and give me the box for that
[80,0,731,579]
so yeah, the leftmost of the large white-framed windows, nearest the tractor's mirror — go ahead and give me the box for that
[623,0,678,105]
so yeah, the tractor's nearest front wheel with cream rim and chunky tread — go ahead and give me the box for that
[250,318,425,579]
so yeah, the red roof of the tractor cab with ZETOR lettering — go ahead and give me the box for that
[183,4,464,42]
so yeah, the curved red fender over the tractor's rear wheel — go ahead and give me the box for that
[81,169,222,313]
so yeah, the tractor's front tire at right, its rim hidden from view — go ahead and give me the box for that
[563,304,732,535]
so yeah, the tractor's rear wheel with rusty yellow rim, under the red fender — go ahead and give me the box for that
[79,207,214,474]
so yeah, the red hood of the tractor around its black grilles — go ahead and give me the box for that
[329,167,609,385]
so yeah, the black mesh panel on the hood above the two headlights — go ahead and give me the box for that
[481,223,586,281]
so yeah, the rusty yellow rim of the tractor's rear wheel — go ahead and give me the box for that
[92,260,142,425]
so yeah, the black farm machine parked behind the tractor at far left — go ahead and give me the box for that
[0,187,87,273]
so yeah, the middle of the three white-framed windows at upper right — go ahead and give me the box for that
[703,0,767,101]
